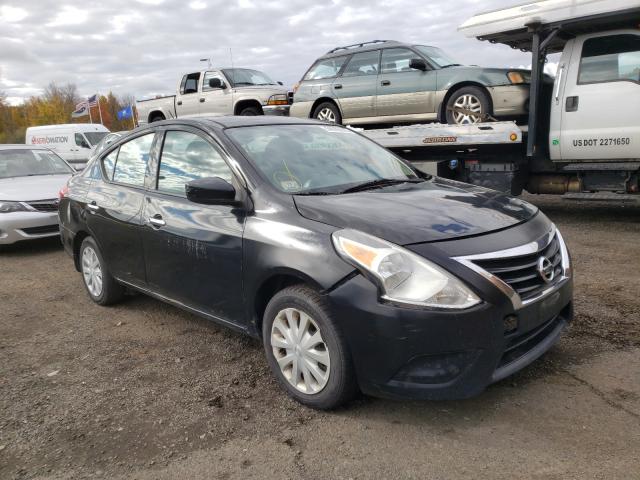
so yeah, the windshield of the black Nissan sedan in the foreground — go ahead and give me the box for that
[226,125,419,195]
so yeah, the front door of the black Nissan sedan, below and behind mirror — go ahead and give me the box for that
[143,127,245,325]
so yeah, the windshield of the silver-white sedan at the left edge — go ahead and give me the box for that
[0,149,75,178]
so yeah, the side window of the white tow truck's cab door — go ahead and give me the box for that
[578,34,640,84]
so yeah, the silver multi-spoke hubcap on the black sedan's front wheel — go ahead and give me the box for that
[271,308,331,394]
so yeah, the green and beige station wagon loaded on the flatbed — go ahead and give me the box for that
[290,40,531,125]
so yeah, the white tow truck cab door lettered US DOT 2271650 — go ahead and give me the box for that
[551,30,640,160]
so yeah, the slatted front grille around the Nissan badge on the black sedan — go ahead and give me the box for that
[473,235,562,300]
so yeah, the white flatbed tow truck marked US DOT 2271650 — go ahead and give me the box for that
[361,0,640,202]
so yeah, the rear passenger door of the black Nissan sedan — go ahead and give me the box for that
[85,131,155,285]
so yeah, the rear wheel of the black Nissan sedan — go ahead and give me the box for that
[79,237,125,305]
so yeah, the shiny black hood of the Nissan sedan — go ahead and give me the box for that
[294,178,538,245]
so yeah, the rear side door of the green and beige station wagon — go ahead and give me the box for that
[333,50,380,119]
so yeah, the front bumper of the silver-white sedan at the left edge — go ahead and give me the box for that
[0,212,60,245]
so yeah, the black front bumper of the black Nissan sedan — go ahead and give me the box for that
[329,275,573,400]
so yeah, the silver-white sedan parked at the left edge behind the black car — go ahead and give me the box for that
[0,145,75,244]
